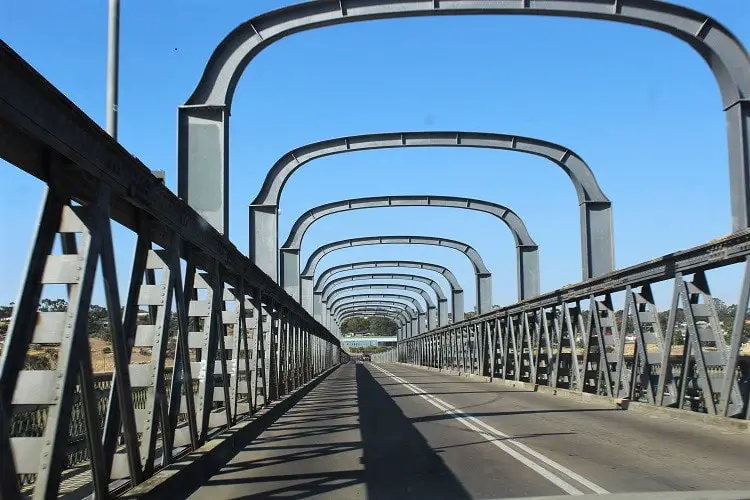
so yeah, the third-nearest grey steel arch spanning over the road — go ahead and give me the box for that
[282,195,540,300]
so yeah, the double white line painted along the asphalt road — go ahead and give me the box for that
[370,365,609,495]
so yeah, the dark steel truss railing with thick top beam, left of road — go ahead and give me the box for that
[0,42,343,499]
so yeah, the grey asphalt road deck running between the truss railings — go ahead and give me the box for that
[191,363,750,500]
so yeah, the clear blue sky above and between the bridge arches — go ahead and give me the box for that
[0,0,750,310]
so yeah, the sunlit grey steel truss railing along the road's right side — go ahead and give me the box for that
[396,230,750,419]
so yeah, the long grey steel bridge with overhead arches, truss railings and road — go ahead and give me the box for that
[0,0,750,499]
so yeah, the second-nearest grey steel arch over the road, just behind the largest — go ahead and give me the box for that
[249,135,614,286]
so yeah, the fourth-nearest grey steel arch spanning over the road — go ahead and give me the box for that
[300,236,492,313]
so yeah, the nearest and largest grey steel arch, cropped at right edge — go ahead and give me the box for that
[178,0,750,248]
